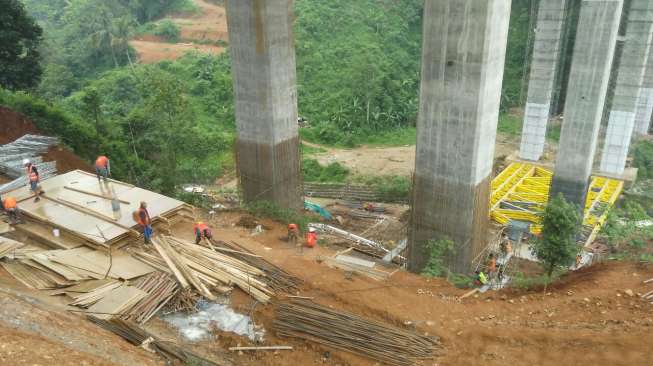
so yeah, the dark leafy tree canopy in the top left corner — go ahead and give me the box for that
[0,0,43,90]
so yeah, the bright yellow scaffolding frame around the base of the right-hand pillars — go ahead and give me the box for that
[490,162,624,245]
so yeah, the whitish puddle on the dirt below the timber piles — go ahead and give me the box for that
[163,302,265,342]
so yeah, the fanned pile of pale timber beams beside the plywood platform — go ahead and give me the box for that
[134,236,274,303]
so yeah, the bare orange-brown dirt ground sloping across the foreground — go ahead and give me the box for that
[0,212,653,366]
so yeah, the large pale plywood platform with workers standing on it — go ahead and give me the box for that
[8,170,192,248]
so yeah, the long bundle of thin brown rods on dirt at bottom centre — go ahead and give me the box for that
[274,299,439,366]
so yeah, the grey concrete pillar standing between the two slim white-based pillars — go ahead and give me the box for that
[550,0,623,209]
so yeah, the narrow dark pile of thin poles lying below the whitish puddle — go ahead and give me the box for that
[88,316,223,366]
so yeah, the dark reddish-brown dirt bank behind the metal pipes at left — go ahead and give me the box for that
[0,107,93,173]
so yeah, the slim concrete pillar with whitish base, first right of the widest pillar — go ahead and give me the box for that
[519,0,567,161]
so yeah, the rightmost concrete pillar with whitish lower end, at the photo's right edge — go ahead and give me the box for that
[600,0,653,175]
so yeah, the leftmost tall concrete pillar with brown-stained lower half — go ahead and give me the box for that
[227,0,302,209]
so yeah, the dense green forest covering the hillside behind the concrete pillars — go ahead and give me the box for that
[0,0,648,200]
